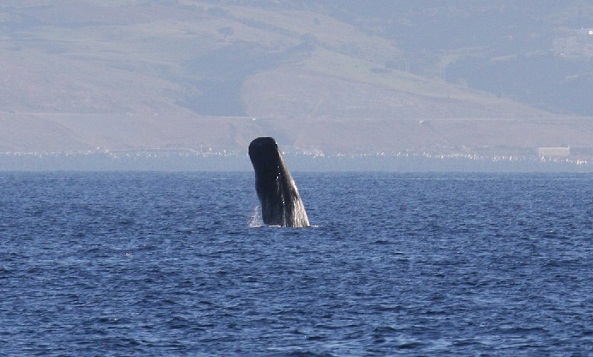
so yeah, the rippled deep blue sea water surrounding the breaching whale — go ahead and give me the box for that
[0,172,593,356]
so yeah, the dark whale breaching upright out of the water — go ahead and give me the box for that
[249,137,310,227]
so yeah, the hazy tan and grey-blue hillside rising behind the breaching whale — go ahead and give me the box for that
[0,0,593,165]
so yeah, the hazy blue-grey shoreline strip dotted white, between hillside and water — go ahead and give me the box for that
[0,151,593,173]
